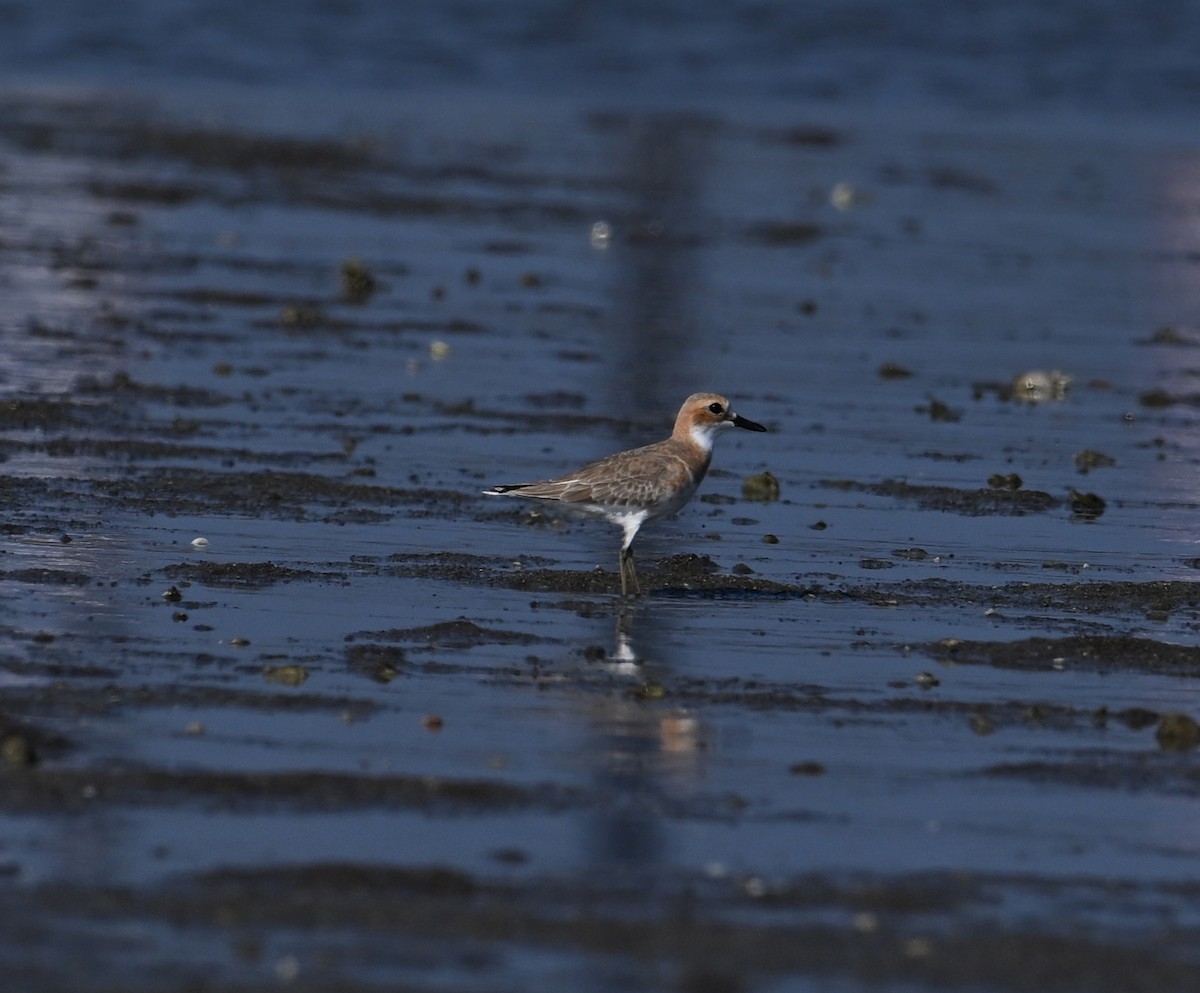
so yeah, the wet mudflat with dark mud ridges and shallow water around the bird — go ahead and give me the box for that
[0,92,1200,991]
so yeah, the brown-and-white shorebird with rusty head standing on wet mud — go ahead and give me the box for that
[484,393,767,596]
